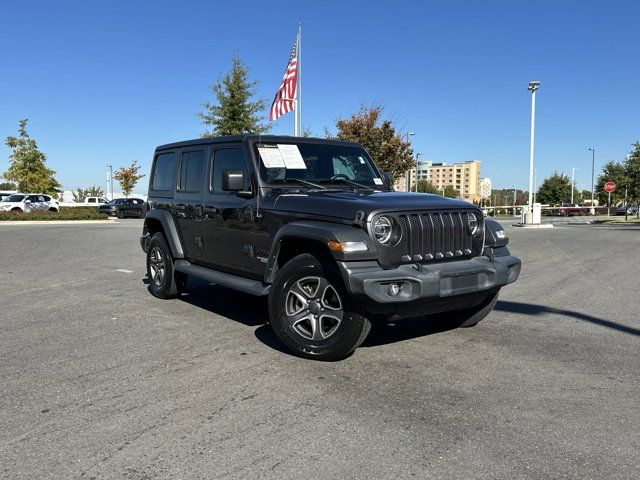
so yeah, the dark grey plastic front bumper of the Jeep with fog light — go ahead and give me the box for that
[338,255,520,304]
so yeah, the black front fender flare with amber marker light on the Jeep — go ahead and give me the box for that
[264,220,378,284]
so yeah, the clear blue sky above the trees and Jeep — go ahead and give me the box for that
[0,0,640,191]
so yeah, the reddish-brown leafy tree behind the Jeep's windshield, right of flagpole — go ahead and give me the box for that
[325,106,415,181]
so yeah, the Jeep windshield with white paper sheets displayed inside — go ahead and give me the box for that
[256,143,384,190]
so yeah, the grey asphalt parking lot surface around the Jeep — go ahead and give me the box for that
[0,220,640,479]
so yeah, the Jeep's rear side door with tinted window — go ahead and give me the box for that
[172,146,208,260]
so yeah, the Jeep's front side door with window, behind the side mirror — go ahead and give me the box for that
[202,144,256,270]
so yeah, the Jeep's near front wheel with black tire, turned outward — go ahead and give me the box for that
[269,254,371,361]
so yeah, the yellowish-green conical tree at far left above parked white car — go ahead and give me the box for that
[4,119,60,195]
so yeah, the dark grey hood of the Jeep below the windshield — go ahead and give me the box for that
[264,192,475,220]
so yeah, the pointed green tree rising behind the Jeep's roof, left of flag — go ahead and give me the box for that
[198,55,270,137]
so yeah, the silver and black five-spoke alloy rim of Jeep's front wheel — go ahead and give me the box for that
[285,276,344,341]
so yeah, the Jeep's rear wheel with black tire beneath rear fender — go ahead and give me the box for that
[147,232,187,299]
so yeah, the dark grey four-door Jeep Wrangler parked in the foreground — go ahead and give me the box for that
[141,136,520,360]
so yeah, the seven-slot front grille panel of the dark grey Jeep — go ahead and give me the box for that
[373,210,482,266]
